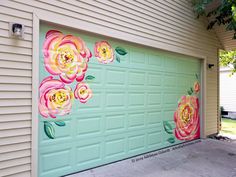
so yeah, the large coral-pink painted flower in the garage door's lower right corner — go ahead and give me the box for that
[174,95,200,140]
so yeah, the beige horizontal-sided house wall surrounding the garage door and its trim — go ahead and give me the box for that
[0,0,219,177]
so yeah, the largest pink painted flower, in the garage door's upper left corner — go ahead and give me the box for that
[43,30,92,83]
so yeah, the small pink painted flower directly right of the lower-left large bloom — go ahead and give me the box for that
[74,82,92,103]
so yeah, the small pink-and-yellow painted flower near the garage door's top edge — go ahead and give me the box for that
[94,41,114,64]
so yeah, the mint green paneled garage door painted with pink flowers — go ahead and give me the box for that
[38,24,200,177]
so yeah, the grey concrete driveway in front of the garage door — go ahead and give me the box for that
[67,139,236,177]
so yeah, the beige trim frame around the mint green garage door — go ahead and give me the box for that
[31,9,207,177]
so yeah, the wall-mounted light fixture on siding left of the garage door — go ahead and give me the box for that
[9,23,25,38]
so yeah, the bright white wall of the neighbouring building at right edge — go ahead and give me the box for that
[220,68,236,112]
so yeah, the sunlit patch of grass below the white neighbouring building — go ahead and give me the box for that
[220,118,236,135]
